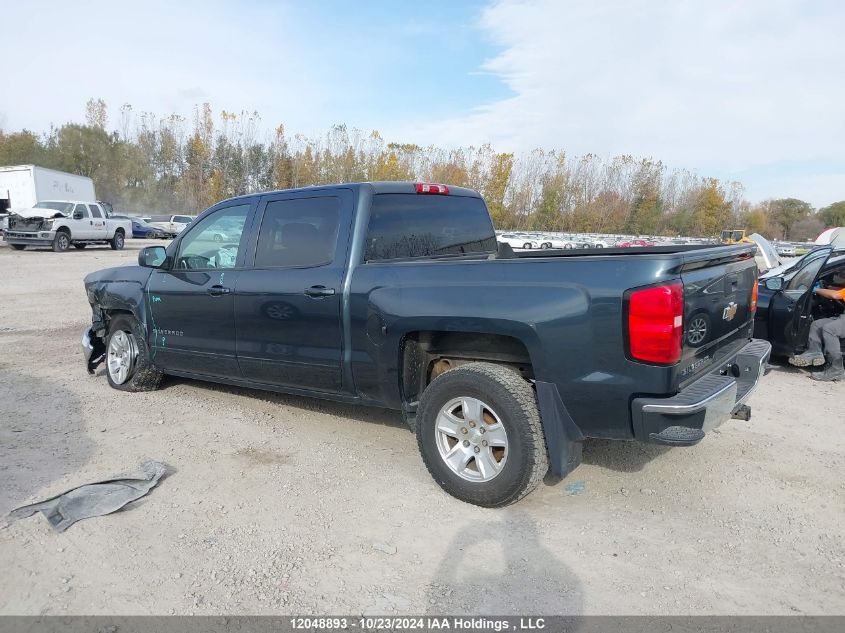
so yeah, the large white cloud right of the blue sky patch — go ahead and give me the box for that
[421,0,845,202]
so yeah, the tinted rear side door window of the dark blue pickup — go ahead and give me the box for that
[255,196,340,268]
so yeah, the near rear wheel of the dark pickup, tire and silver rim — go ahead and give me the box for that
[416,363,549,508]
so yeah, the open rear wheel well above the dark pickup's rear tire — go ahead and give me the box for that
[400,331,534,408]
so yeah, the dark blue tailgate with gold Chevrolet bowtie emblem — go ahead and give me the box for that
[675,245,757,388]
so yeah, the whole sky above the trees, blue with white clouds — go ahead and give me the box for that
[0,0,845,208]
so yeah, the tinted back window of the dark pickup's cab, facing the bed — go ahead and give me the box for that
[364,193,496,261]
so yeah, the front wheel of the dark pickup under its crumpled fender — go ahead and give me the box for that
[106,315,162,391]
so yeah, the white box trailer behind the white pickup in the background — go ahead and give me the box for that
[0,165,97,213]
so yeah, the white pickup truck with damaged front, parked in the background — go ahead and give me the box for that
[3,200,132,253]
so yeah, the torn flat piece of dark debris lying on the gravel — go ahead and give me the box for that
[9,460,167,532]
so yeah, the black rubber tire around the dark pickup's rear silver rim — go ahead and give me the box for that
[416,363,549,508]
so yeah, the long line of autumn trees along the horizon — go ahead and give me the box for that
[0,99,845,240]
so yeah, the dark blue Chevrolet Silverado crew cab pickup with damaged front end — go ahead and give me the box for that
[82,182,771,506]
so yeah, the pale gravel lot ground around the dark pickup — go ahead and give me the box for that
[0,240,845,614]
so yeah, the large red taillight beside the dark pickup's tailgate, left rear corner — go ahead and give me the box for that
[626,282,684,365]
